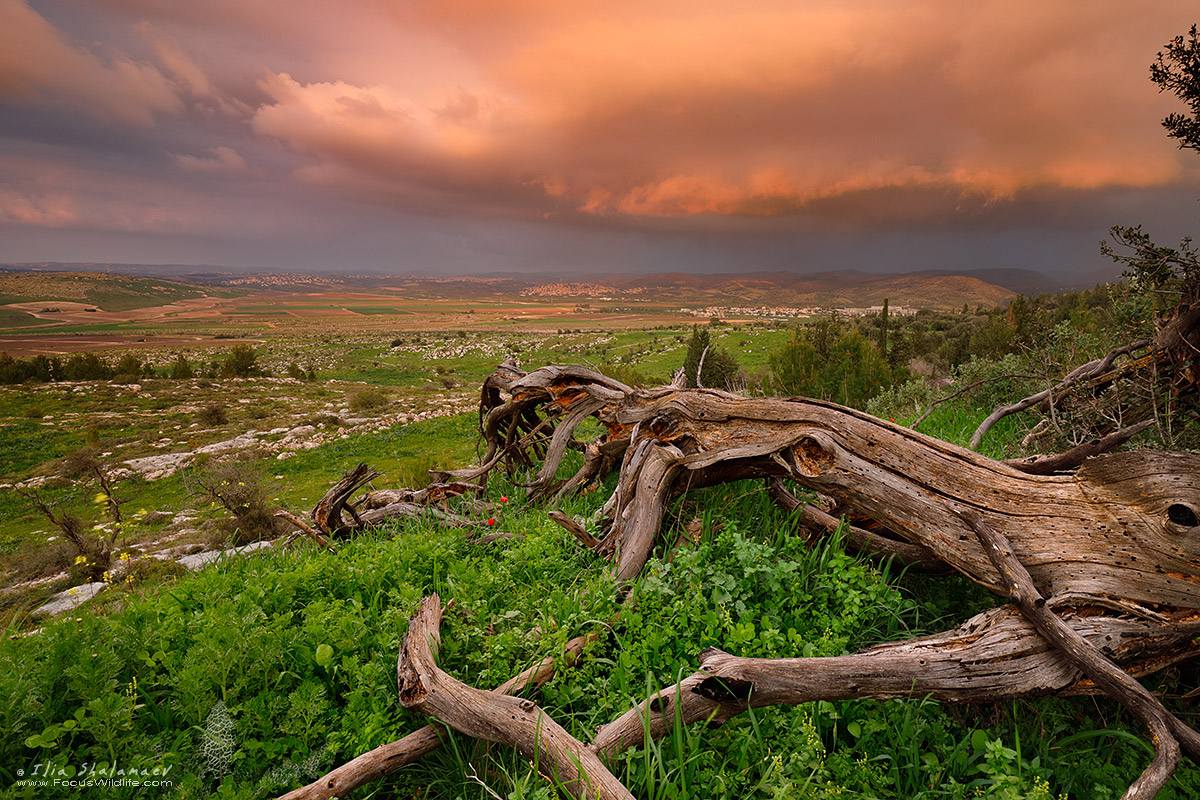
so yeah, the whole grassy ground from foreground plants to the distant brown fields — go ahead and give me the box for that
[0,272,1200,800]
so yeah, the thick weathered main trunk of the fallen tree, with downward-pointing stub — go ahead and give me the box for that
[605,389,1200,614]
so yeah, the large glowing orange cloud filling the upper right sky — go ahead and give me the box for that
[241,0,1192,217]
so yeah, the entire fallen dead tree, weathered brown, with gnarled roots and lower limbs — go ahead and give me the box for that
[285,316,1200,798]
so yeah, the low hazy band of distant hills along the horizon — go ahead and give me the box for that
[0,264,1022,311]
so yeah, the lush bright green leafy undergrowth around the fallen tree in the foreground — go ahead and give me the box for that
[0,472,1200,799]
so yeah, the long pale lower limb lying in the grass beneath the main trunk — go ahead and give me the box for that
[590,606,1200,758]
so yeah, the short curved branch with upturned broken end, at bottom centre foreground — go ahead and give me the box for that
[396,595,634,800]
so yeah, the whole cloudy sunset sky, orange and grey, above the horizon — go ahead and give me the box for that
[0,0,1200,281]
